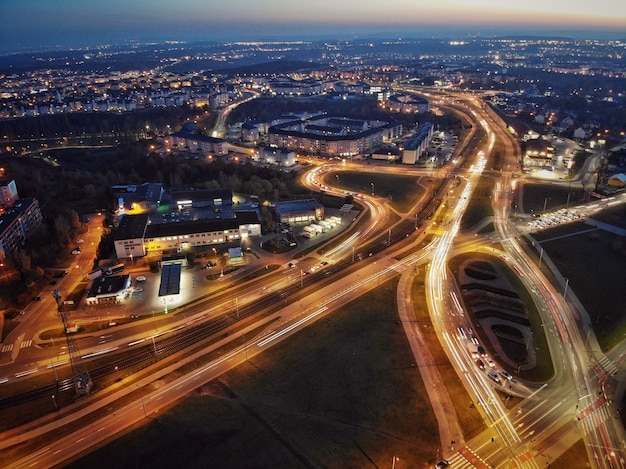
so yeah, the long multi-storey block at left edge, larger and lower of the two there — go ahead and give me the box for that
[0,199,43,260]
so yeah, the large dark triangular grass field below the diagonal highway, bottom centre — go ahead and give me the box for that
[71,281,439,469]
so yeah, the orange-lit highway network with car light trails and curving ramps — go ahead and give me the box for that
[0,86,626,468]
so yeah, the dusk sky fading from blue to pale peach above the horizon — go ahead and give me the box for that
[0,0,626,53]
